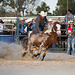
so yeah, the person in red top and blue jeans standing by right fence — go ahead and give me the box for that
[66,21,74,55]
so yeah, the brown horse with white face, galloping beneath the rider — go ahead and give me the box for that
[22,22,61,61]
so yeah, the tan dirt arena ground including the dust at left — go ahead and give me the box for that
[0,42,75,75]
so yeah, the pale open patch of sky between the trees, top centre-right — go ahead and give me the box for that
[41,0,58,13]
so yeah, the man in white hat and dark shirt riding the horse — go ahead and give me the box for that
[35,11,48,35]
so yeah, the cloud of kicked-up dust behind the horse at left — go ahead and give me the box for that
[0,42,31,60]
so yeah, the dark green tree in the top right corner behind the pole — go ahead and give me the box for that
[53,0,75,16]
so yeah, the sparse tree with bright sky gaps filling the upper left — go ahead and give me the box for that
[0,0,37,16]
